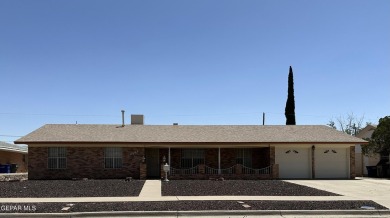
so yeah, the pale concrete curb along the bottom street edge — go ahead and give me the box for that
[0,210,390,218]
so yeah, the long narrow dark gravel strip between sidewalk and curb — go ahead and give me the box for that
[0,201,387,213]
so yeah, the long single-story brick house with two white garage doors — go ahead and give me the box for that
[15,116,366,179]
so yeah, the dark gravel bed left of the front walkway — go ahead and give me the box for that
[0,180,145,198]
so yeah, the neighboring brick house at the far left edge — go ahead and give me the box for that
[0,142,28,173]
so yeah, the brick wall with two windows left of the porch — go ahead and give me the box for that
[28,147,144,179]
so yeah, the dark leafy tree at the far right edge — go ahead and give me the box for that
[362,116,390,156]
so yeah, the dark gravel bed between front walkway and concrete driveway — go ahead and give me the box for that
[161,180,340,196]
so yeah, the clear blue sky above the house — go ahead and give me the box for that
[0,0,390,142]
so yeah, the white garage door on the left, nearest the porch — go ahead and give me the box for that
[275,148,311,179]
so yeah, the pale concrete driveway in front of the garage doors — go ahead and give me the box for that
[285,177,390,208]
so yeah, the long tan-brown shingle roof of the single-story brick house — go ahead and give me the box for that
[15,124,366,144]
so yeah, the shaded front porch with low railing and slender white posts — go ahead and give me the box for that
[140,147,279,179]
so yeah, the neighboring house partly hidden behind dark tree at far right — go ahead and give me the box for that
[355,124,381,176]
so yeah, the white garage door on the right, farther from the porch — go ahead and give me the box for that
[315,147,349,179]
